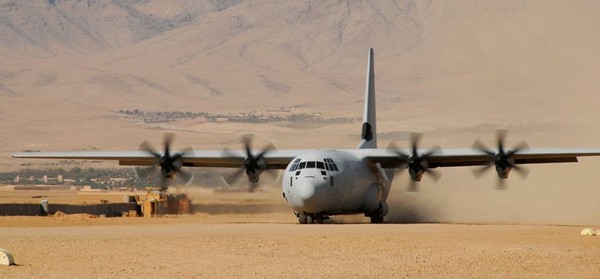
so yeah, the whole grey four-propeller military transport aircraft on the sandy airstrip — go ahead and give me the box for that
[13,49,600,224]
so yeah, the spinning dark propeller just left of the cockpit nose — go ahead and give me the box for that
[224,135,274,192]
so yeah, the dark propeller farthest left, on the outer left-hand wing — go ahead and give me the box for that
[140,133,193,189]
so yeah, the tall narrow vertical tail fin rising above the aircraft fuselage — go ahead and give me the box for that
[358,48,377,149]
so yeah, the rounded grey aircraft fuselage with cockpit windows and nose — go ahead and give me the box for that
[281,150,386,222]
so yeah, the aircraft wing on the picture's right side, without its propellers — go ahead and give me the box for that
[360,148,600,168]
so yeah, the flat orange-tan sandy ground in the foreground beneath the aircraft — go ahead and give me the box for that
[0,191,600,278]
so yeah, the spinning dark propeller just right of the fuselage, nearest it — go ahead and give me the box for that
[394,133,441,192]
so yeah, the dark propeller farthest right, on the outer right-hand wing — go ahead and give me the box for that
[472,130,529,189]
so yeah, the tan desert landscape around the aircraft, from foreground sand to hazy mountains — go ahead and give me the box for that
[0,0,600,278]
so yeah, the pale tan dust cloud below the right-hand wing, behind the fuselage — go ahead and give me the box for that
[386,163,600,225]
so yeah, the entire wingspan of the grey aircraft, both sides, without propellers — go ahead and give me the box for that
[13,148,600,169]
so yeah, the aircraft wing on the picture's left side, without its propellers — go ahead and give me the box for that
[12,150,306,169]
